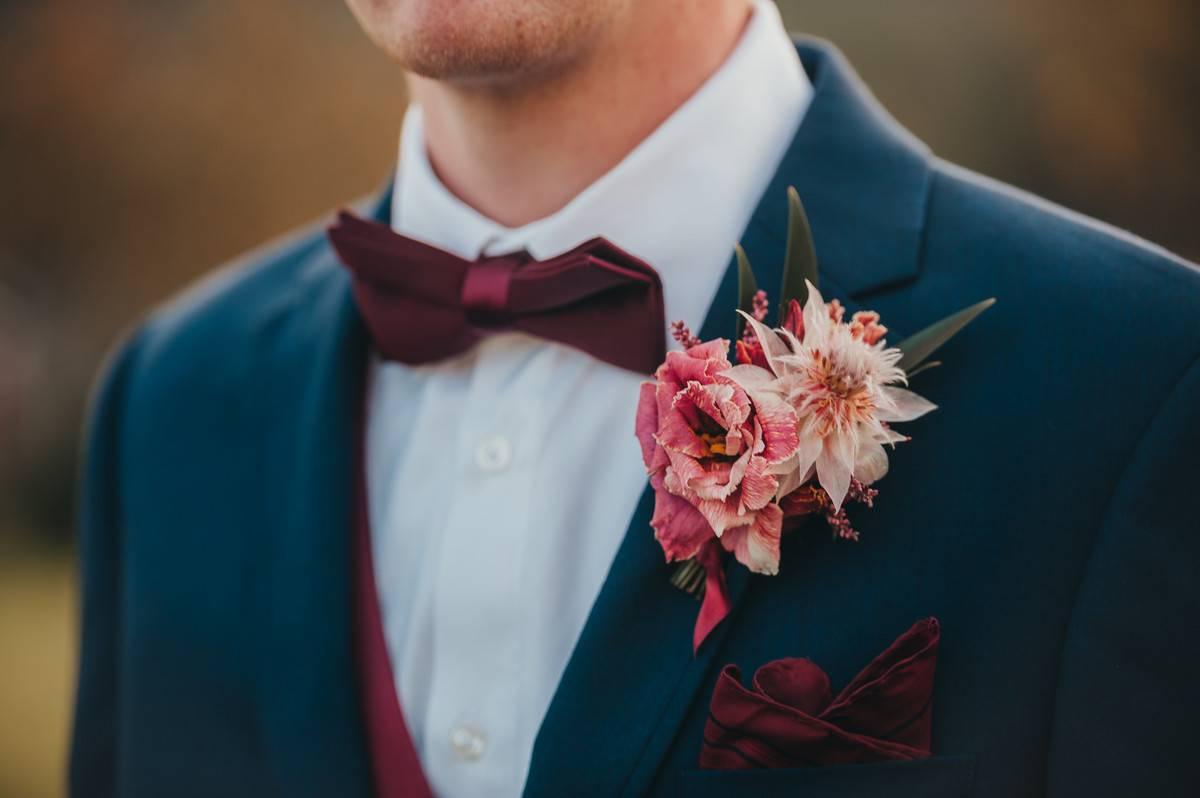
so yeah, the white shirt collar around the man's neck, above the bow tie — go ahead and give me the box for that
[392,0,812,338]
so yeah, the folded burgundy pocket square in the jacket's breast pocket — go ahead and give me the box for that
[700,618,941,770]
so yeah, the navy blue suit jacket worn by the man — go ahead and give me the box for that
[71,42,1200,798]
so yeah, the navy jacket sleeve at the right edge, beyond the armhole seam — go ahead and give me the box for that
[1046,360,1200,798]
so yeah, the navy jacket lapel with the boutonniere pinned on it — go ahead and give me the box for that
[524,34,929,798]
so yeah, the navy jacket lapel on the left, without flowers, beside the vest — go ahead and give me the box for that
[259,189,390,798]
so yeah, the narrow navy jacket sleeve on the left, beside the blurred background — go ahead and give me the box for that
[67,328,144,798]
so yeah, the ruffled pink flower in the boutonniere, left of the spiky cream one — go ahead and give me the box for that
[637,340,799,574]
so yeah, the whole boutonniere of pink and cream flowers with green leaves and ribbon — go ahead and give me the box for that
[637,190,995,649]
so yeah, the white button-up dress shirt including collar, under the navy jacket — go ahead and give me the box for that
[367,0,812,797]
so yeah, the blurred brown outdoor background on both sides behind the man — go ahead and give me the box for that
[0,0,1200,797]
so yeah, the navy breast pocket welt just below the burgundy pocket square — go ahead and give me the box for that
[679,755,976,798]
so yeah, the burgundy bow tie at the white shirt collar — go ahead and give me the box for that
[329,211,666,374]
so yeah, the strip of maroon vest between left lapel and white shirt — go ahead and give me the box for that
[353,405,433,798]
